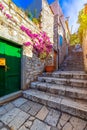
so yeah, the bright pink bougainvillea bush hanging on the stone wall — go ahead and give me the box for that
[20,25,53,59]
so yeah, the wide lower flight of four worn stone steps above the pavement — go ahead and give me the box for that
[23,71,87,120]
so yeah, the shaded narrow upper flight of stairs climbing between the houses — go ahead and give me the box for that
[59,50,84,71]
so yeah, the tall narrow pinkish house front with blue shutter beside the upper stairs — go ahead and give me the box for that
[50,0,69,69]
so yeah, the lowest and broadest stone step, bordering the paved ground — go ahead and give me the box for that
[23,89,87,120]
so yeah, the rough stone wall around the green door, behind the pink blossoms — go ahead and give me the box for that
[0,0,44,89]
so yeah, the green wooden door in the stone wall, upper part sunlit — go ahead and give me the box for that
[0,40,21,96]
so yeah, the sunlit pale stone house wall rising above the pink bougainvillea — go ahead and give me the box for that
[41,0,54,43]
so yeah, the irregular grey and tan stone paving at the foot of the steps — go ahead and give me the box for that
[0,98,87,130]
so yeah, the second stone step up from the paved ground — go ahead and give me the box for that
[31,82,87,100]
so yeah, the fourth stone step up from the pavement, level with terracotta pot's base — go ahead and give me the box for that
[42,71,87,80]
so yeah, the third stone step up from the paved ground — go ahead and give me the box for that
[38,77,87,88]
